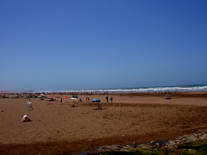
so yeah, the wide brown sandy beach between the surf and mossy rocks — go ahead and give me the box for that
[0,92,207,155]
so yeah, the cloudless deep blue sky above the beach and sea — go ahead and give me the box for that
[0,0,207,91]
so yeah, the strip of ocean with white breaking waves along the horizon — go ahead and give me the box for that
[34,84,207,93]
